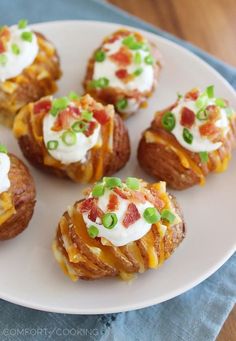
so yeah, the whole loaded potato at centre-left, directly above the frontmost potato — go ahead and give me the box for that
[13,92,130,182]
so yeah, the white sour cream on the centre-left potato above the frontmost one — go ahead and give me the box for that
[43,109,101,164]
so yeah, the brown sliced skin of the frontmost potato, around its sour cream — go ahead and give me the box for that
[54,195,186,280]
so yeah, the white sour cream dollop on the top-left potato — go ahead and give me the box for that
[0,26,39,82]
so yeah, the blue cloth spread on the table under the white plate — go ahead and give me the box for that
[0,0,236,341]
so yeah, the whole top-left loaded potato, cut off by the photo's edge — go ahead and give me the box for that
[0,20,61,127]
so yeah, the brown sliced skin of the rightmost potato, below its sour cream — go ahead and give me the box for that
[137,107,236,190]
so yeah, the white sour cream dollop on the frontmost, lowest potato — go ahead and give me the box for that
[82,189,154,246]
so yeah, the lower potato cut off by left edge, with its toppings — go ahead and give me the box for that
[0,145,36,240]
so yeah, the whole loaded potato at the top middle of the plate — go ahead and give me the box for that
[84,29,162,118]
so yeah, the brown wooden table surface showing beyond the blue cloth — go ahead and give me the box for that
[108,0,236,341]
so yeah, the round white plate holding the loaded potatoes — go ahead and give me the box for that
[0,21,236,314]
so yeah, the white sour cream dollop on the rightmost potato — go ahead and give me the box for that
[171,98,229,153]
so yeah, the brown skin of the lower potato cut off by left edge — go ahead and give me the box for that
[0,154,36,240]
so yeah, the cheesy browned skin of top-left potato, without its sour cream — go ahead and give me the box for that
[0,32,61,127]
